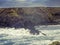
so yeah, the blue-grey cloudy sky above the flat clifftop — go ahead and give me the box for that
[0,0,60,8]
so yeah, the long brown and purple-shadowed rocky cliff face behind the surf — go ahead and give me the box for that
[0,7,60,27]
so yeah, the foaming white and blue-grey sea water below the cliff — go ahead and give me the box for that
[0,25,60,45]
